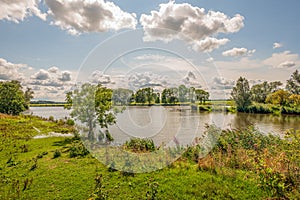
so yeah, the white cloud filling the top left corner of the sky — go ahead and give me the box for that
[0,0,47,23]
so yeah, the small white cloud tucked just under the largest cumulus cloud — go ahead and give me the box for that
[192,37,229,52]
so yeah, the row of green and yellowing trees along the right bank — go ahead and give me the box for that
[231,70,300,112]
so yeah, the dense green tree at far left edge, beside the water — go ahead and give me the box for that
[0,81,29,115]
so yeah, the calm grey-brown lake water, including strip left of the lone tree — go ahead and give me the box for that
[29,106,300,145]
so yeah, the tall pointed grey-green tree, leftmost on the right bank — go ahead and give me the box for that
[231,77,251,112]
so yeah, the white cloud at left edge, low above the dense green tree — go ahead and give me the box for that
[0,58,27,80]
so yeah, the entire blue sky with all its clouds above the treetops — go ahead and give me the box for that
[0,0,300,101]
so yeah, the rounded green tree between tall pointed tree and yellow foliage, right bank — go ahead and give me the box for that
[250,81,282,103]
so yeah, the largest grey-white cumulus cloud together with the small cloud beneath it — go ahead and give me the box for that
[140,1,244,51]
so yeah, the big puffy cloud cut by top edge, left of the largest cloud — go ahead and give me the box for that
[45,0,137,35]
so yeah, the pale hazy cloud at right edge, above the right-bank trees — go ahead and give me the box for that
[263,51,300,68]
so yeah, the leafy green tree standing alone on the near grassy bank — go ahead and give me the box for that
[66,83,115,140]
